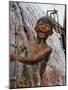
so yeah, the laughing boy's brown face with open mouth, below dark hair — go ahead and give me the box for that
[37,23,51,39]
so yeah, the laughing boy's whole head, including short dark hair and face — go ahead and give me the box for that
[35,17,53,39]
